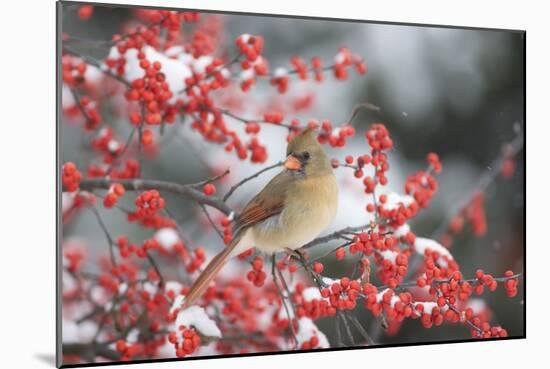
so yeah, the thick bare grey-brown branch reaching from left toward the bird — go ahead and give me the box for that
[80,178,233,215]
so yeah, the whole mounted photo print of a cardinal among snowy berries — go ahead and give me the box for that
[57,1,525,367]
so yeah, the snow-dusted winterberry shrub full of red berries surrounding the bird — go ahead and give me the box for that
[60,5,522,363]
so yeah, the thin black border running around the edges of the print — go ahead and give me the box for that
[55,0,527,368]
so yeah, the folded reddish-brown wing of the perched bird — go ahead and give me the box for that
[235,172,295,232]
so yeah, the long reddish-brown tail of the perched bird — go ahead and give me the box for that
[182,232,244,309]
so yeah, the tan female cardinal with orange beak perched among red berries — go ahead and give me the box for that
[181,128,338,309]
